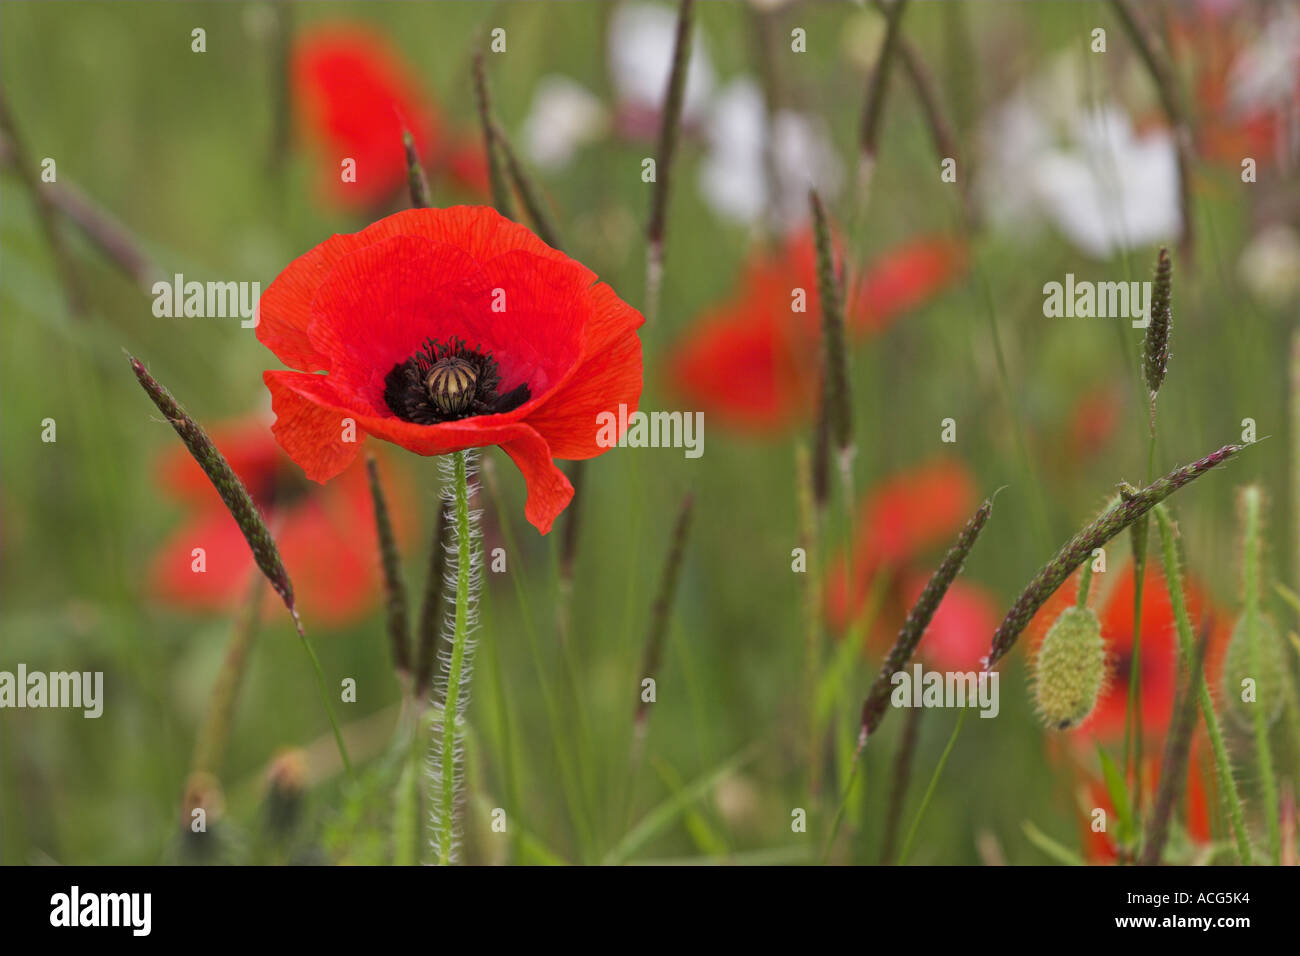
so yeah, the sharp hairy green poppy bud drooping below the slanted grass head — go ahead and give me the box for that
[1034,607,1106,730]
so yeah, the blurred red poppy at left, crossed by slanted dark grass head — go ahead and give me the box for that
[151,418,410,623]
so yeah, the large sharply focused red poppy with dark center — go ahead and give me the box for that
[257,206,644,535]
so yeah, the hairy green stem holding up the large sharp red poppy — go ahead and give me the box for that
[434,451,475,866]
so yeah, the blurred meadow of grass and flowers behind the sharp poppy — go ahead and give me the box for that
[0,0,1300,864]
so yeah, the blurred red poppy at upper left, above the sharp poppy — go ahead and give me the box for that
[291,22,488,209]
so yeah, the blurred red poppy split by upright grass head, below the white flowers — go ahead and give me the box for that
[670,232,965,433]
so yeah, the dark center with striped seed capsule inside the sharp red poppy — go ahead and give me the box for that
[384,338,529,425]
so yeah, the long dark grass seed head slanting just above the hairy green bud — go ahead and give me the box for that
[987,445,1242,669]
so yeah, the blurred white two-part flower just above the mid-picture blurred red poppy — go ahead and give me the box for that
[699,77,842,230]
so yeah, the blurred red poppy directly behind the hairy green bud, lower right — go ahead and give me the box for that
[1026,559,1231,740]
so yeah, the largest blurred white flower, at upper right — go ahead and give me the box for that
[976,61,1182,259]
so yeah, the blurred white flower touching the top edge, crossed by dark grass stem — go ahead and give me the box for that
[608,3,714,122]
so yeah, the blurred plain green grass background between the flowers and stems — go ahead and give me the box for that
[0,3,1296,864]
